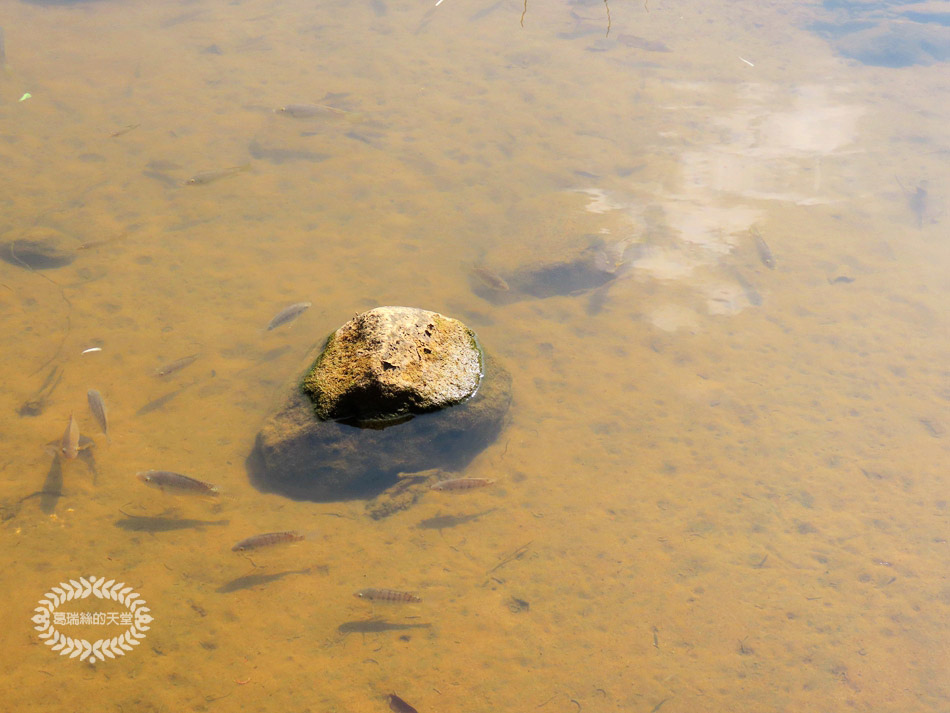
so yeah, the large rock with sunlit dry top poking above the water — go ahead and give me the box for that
[247,308,511,500]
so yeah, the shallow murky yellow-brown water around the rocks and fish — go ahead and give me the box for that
[0,0,950,713]
